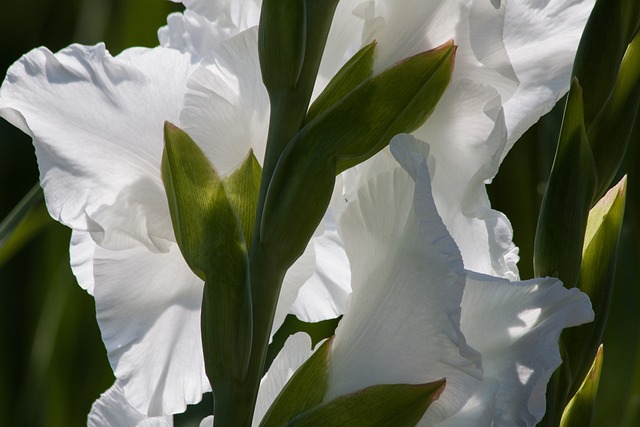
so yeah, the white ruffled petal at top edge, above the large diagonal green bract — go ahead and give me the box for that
[327,0,517,97]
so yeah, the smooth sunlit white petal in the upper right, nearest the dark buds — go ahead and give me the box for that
[504,0,594,155]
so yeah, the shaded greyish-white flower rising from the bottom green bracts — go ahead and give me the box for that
[326,135,593,426]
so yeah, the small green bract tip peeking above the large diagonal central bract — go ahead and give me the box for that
[306,41,377,123]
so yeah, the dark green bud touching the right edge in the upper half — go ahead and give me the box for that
[587,33,640,200]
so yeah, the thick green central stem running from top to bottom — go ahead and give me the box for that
[213,0,338,427]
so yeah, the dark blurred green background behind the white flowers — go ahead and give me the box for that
[0,0,640,426]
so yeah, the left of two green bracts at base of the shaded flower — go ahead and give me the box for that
[260,338,333,427]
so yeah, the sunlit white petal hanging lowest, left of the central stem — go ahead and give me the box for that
[94,245,210,416]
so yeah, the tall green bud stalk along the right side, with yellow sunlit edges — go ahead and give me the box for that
[534,0,640,425]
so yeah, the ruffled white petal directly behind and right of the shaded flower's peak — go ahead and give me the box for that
[414,89,519,280]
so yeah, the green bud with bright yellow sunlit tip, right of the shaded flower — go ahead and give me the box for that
[562,177,627,394]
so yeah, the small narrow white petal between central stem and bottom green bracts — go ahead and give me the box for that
[253,332,313,426]
